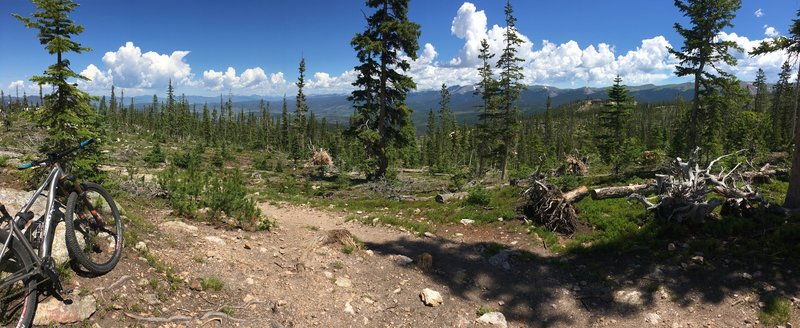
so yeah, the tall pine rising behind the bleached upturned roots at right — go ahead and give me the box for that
[669,0,742,156]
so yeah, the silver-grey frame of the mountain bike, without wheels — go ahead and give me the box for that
[0,162,64,289]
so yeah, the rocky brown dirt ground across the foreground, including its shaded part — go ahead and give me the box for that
[0,183,800,327]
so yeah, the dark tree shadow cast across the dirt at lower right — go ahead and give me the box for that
[366,213,800,326]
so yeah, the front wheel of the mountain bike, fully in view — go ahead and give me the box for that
[64,183,122,274]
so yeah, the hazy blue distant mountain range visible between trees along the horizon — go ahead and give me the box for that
[6,83,736,127]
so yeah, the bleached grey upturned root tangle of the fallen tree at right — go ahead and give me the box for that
[628,148,764,224]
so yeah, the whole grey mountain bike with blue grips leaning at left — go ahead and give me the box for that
[0,139,123,327]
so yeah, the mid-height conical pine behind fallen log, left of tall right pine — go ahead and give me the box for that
[598,75,633,175]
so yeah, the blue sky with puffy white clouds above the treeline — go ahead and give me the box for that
[0,0,800,96]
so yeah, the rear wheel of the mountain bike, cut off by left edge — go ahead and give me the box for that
[0,231,38,327]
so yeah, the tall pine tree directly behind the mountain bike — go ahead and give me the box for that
[14,0,101,180]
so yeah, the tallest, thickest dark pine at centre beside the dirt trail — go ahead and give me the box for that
[348,0,420,180]
